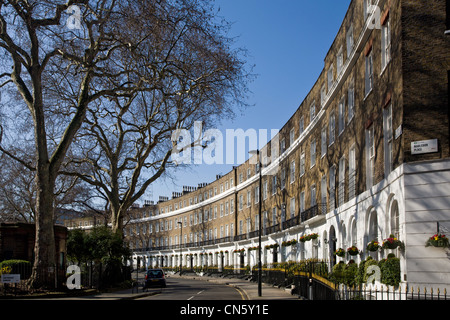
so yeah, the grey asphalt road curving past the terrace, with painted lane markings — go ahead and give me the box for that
[139,277,245,301]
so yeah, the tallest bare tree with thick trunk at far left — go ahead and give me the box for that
[0,0,176,288]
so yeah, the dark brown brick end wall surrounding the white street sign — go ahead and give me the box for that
[402,0,450,162]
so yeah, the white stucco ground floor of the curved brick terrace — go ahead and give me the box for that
[134,159,450,292]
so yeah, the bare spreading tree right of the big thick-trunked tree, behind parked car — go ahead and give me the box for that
[64,0,250,232]
